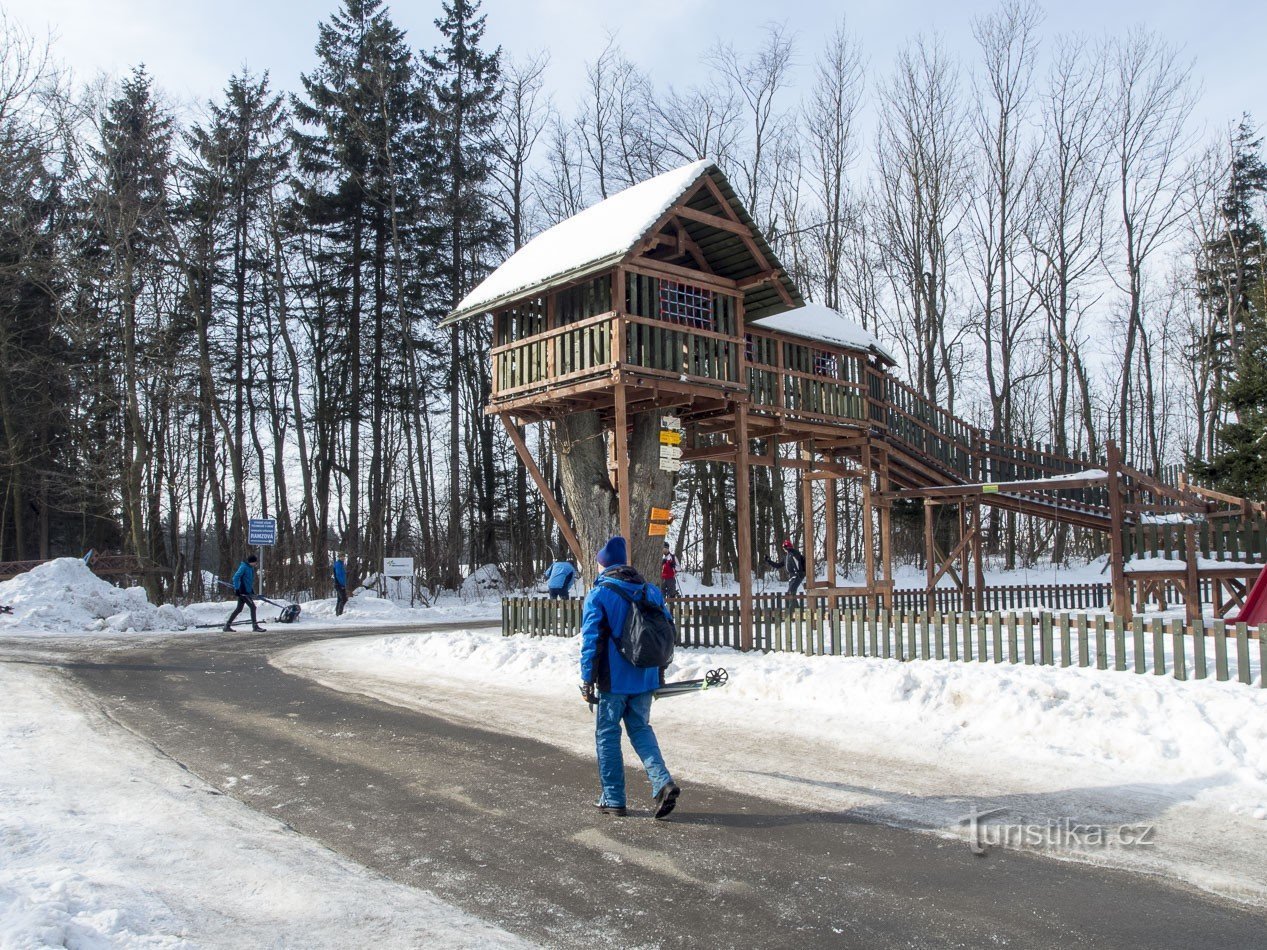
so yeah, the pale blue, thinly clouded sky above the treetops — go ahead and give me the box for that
[5,0,1267,129]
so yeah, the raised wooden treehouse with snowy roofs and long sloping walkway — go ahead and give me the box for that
[446,161,1263,645]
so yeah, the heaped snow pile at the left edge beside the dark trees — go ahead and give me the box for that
[0,557,189,633]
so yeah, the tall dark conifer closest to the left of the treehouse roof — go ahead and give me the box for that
[423,0,504,585]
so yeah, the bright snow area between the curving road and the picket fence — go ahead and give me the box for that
[274,631,1267,904]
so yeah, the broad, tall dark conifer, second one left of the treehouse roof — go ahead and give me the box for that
[293,0,431,585]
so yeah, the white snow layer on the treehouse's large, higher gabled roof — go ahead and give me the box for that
[446,158,713,323]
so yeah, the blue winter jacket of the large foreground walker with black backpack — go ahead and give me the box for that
[580,564,672,695]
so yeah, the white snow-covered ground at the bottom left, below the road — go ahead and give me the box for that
[0,664,523,950]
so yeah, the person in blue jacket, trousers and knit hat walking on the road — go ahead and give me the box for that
[580,535,679,818]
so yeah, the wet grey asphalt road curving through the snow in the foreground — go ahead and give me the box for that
[5,624,1267,950]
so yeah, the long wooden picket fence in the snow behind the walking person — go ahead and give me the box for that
[502,592,1267,687]
